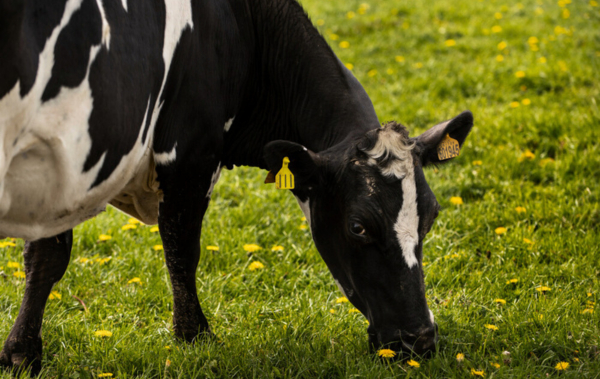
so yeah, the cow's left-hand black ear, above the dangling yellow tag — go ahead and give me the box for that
[264,141,320,188]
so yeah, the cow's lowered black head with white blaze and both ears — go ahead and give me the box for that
[265,112,473,354]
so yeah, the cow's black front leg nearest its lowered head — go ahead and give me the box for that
[157,164,219,342]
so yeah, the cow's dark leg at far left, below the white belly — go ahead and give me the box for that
[0,230,73,374]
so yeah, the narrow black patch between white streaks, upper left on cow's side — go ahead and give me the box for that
[42,0,102,102]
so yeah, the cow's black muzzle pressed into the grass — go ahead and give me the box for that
[367,324,439,359]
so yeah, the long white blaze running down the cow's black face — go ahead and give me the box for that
[394,154,419,268]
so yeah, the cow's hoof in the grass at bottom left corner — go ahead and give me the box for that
[0,339,42,377]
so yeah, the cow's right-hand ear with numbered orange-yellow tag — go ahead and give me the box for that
[412,111,473,167]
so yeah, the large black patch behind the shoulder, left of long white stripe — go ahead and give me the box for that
[83,0,166,188]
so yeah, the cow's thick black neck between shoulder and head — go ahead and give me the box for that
[224,0,379,168]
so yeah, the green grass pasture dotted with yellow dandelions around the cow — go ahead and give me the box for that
[0,0,600,378]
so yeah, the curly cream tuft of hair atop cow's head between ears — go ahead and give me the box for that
[358,121,415,179]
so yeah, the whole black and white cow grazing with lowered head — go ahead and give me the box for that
[0,0,473,372]
